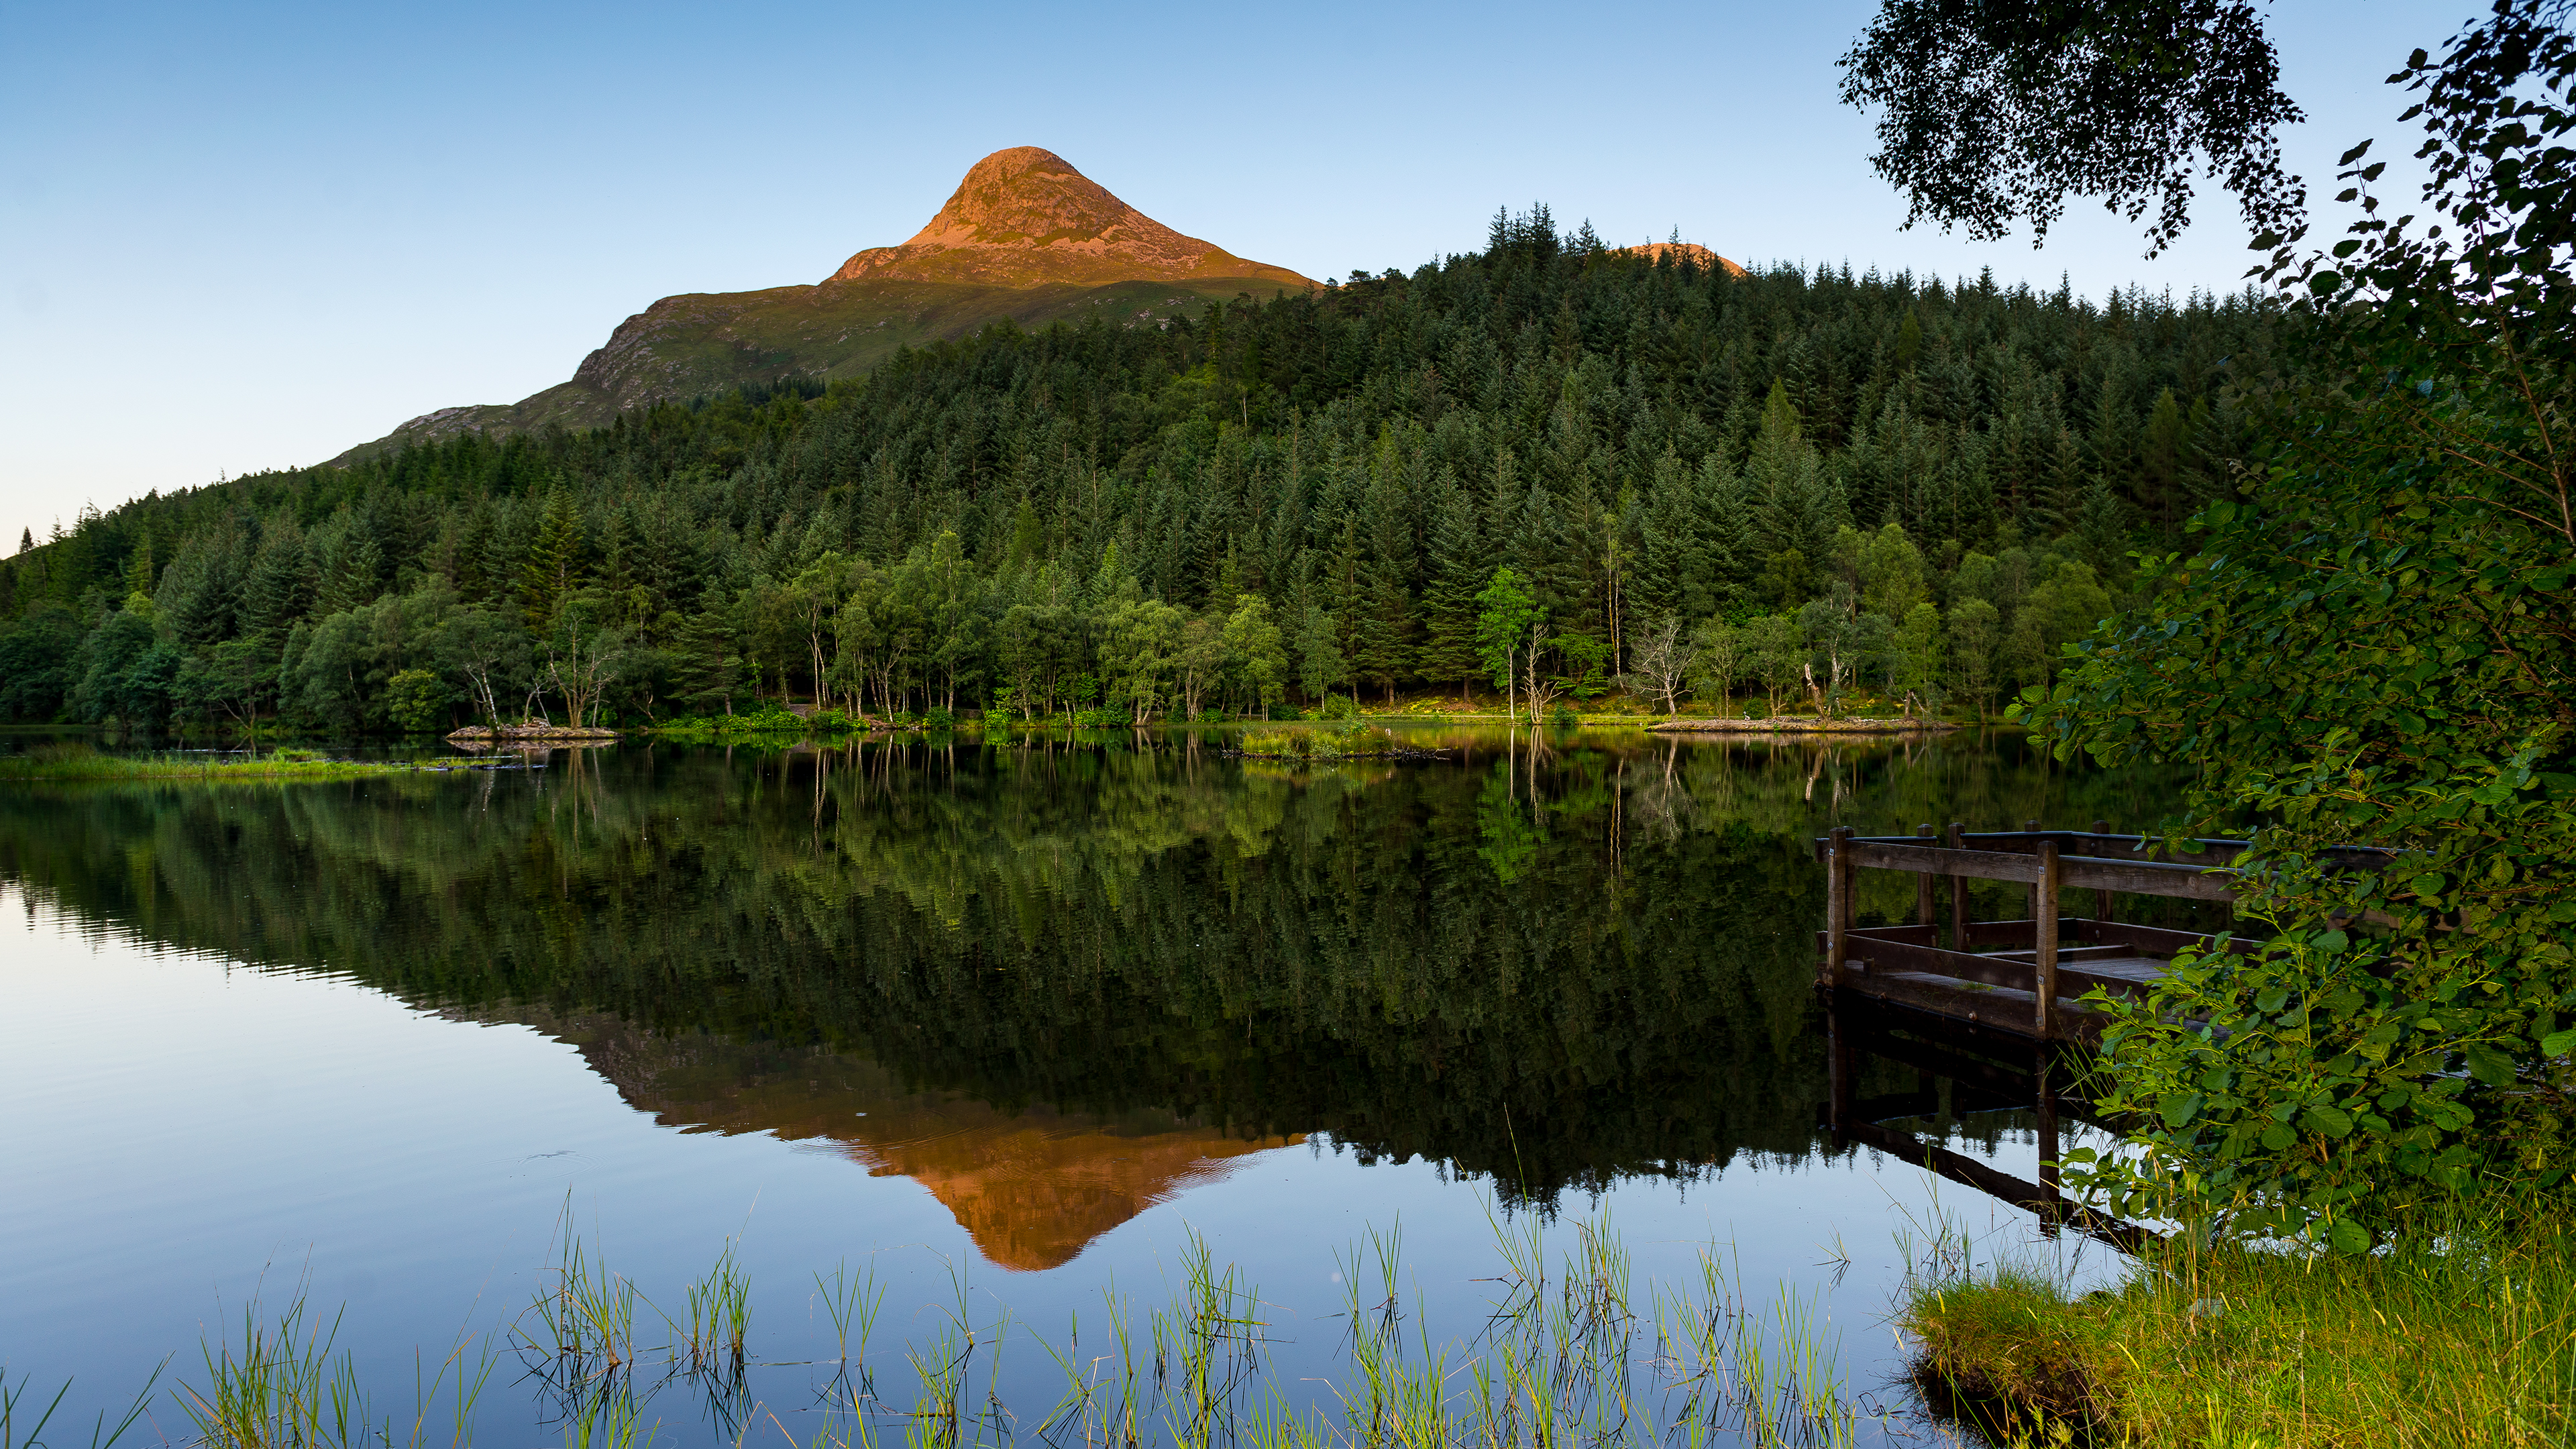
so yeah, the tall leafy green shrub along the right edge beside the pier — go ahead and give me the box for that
[2025,5,2576,1227]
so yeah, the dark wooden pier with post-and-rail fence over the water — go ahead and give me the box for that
[1816,822,2254,1042]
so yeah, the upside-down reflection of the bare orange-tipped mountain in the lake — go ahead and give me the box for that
[523,1011,1303,1271]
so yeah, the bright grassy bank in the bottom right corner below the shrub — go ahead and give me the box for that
[1898,1196,2576,1449]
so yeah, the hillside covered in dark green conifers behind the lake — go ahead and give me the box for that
[0,209,2277,733]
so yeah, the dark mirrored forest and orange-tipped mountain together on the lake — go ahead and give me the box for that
[0,733,2184,1266]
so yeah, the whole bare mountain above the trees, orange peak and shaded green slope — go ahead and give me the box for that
[332,147,1313,462]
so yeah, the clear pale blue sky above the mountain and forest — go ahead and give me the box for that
[0,0,2481,547]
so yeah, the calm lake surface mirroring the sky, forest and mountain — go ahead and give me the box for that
[0,730,2169,1446]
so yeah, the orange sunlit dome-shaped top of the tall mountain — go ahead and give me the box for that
[829,147,1313,286]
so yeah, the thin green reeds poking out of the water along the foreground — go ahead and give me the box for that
[35,1210,1868,1449]
